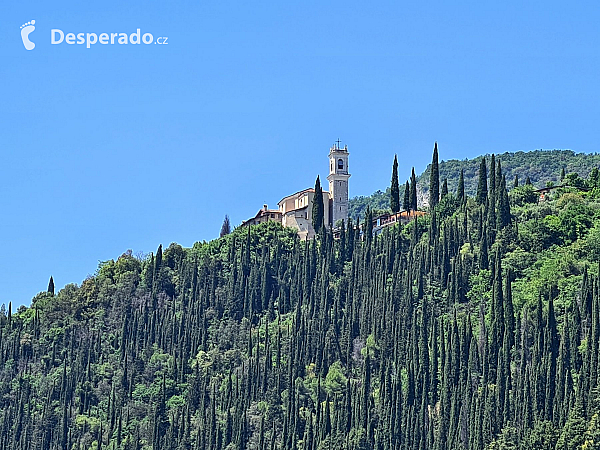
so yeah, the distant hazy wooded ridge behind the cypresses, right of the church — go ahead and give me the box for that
[349,150,600,219]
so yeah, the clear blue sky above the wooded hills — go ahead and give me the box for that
[0,0,600,305]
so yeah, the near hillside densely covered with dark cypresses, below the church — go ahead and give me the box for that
[0,152,600,450]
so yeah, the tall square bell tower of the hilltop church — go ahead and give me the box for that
[327,139,350,226]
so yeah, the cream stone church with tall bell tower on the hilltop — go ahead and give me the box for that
[242,139,350,239]
